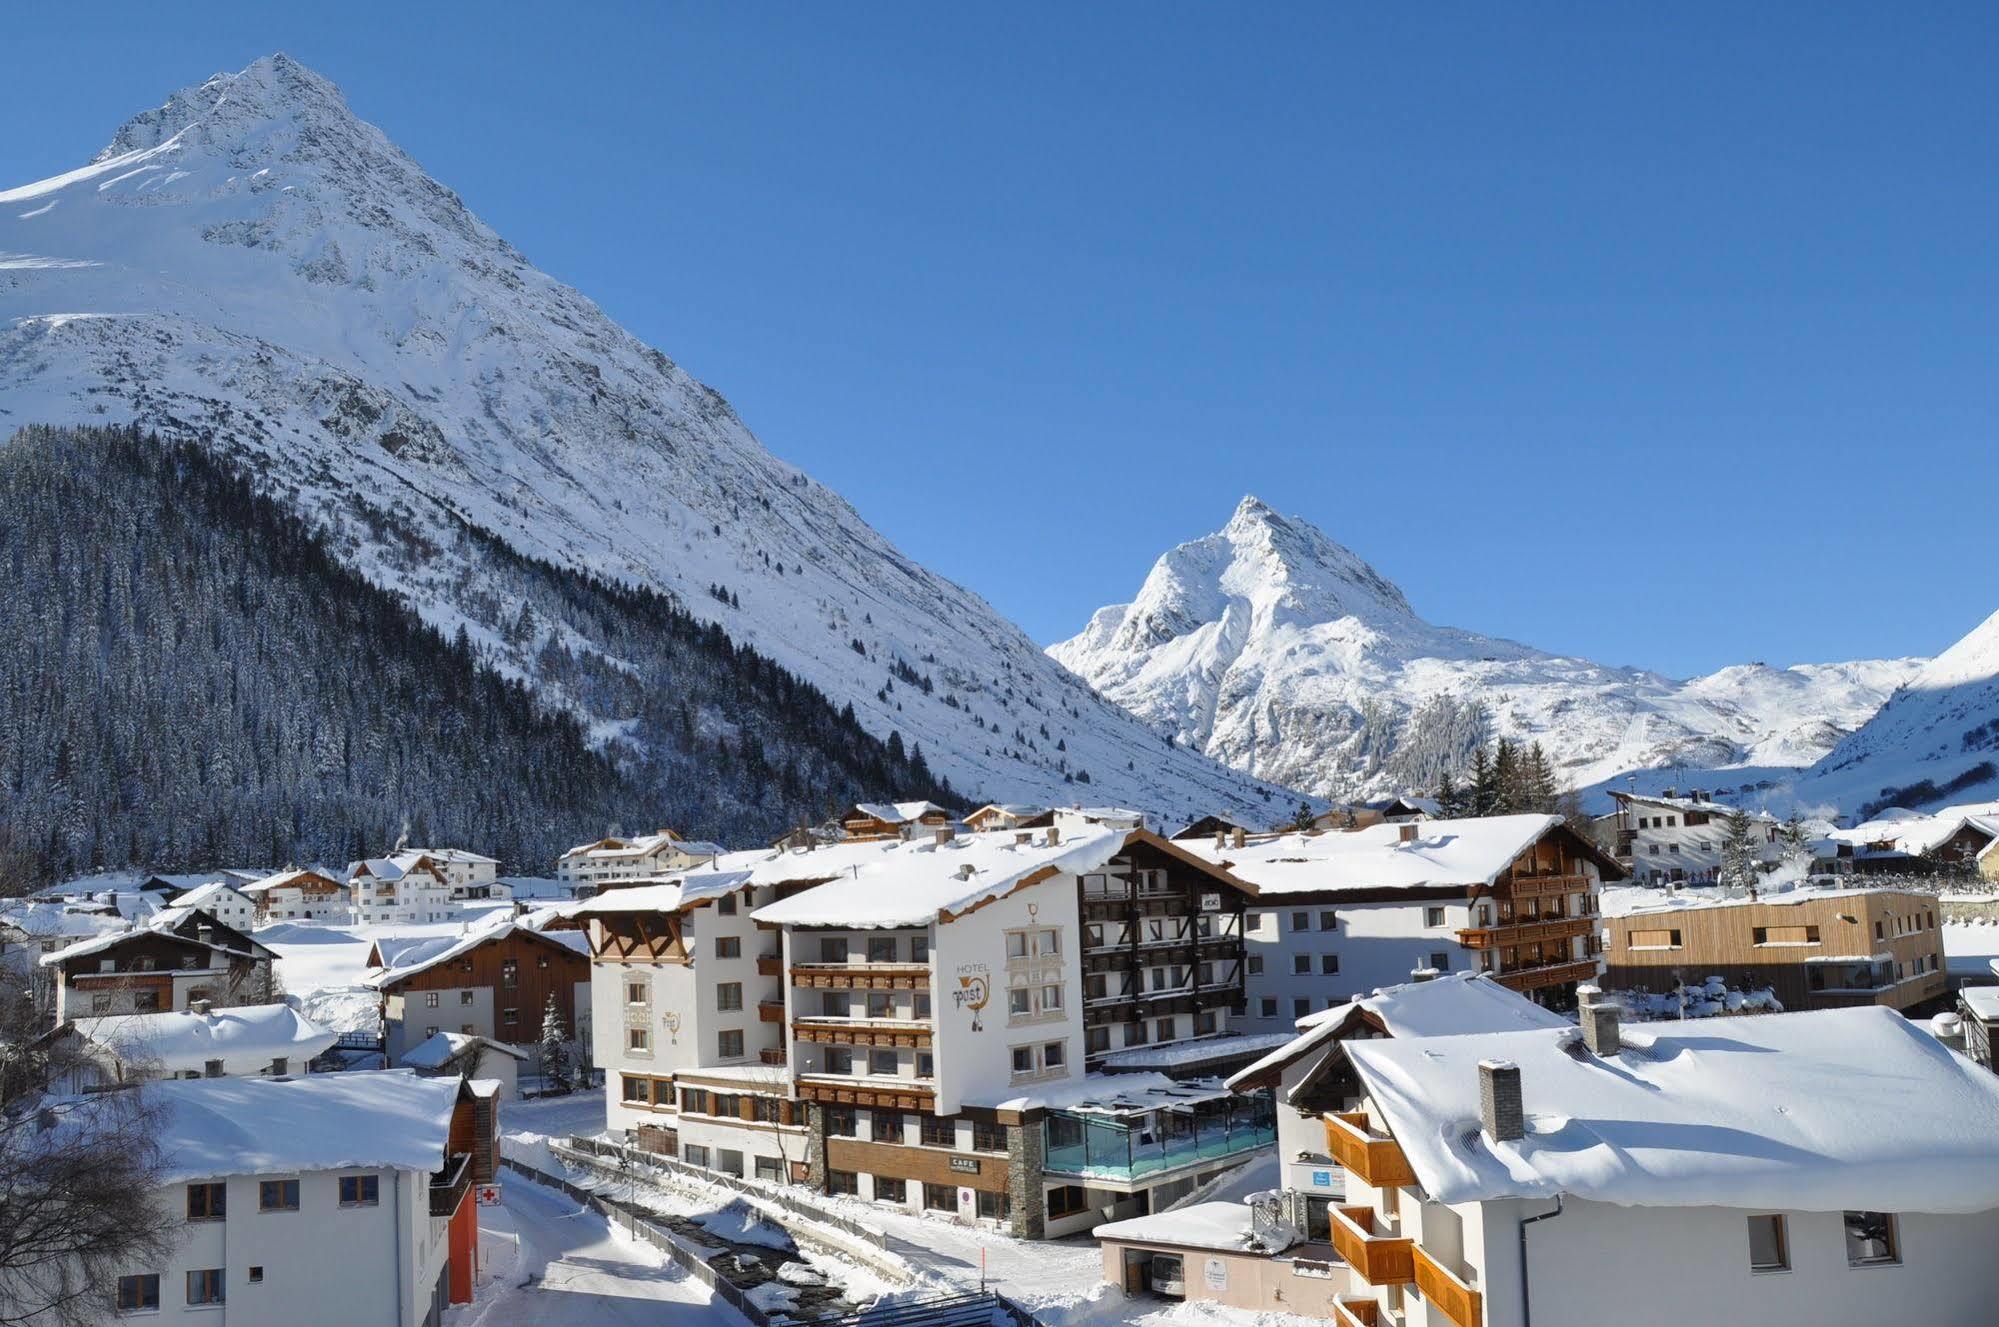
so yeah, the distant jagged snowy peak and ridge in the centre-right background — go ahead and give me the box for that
[1049,498,1923,797]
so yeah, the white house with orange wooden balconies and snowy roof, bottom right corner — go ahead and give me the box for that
[1327,991,1999,1327]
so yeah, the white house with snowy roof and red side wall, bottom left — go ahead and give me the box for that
[102,1071,498,1327]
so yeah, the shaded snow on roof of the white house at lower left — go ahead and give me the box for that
[142,1071,458,1183]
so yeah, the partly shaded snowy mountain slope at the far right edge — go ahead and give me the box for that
[1791,614,1999,813]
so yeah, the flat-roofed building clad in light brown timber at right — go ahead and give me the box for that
[1603,877,1949,1011]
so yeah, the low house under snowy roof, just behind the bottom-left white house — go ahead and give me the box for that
[48,1001,340,1093]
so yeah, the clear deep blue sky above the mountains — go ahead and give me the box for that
[0,4,1999,673]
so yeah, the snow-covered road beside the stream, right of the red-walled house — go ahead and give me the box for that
[446,1173,742,1327]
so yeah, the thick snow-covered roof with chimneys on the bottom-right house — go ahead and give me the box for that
[1345,1005,1999,1213]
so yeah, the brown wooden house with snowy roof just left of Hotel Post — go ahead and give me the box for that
[364,917,590,1063]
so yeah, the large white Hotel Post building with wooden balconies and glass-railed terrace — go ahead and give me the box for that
[578,825,1275,1237]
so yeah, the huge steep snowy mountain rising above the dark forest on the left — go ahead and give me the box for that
[0,56,1287,829]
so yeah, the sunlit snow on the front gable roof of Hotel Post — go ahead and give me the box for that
[751,823,1131,929]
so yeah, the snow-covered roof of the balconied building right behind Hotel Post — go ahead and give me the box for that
[1179,815,1621,895]
